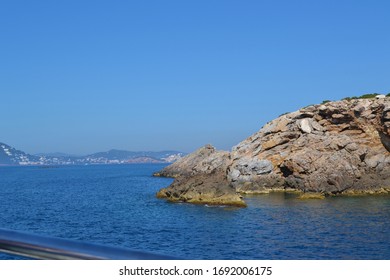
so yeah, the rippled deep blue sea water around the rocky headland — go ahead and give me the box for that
[0,164,390,259]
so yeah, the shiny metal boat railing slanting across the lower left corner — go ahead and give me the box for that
[0,228,175,260]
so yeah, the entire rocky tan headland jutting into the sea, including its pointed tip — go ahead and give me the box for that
[154,95,390,206]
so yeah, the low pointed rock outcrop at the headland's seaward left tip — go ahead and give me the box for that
[154,145,245,207]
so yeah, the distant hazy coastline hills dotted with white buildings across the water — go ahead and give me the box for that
[0,143,185,165]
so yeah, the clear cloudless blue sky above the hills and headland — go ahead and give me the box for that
[0,0,390,154]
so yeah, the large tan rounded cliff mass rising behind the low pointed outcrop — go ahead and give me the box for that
[228,98,390,193]
